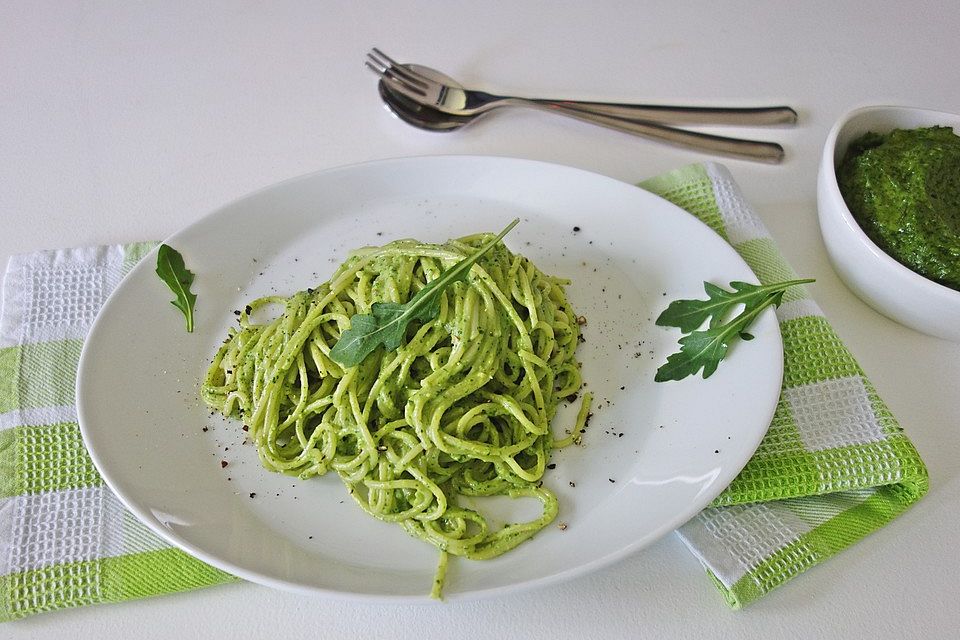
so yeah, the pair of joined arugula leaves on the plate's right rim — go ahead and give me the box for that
[654,279,813,382]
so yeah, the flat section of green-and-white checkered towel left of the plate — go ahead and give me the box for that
[0,244,234,621]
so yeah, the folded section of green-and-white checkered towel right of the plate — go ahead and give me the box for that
[641,164,928,608]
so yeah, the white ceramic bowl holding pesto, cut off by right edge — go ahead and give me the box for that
[817,107,960,342]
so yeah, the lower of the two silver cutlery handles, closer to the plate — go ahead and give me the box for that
[526,101,783,164]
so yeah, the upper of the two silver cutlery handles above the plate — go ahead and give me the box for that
[530,100,797,127]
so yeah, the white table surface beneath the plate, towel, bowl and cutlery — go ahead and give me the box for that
[0,0,960,639]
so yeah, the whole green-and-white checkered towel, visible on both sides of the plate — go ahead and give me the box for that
[0,164,927,620]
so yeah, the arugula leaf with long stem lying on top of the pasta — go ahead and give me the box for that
[330,218,520,367]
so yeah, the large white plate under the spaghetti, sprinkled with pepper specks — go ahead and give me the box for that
[77,156,783,600]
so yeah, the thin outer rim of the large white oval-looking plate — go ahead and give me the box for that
[74,154,784,604]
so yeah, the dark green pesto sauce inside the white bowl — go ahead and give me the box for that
[837,127,960,291]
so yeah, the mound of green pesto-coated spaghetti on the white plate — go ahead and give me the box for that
[202,229,590,597]
